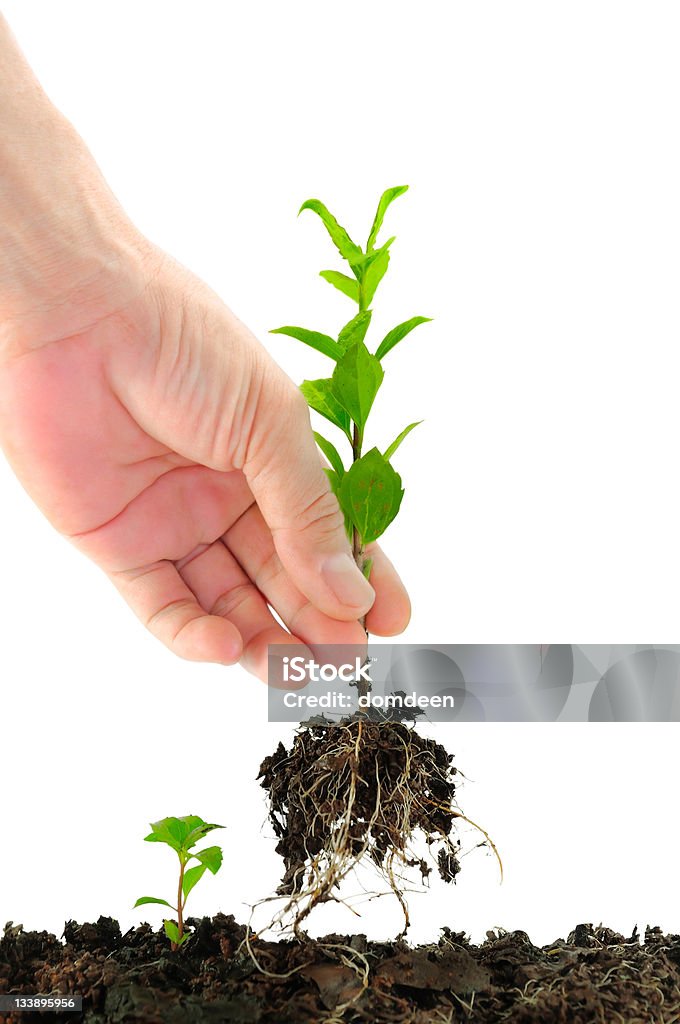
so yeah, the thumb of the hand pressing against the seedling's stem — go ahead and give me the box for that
[244,365,375,620]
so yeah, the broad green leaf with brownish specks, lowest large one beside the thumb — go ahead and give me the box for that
[339,449,403,544]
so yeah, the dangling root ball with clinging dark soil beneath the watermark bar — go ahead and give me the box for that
[259,718,485,938]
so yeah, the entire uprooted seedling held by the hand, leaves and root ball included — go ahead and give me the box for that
[259,185,501,935]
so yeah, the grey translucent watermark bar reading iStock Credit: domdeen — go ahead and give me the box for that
[268,643,680,725]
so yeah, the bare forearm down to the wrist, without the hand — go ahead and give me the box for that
[0,14,151,350]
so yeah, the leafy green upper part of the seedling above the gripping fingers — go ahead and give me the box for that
[271,185,431,606]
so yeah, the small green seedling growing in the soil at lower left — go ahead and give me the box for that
[134,814,224,950]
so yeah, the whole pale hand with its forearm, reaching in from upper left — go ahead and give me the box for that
[0,15,409,677]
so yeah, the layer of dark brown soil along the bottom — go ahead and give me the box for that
[0,914,680,1024]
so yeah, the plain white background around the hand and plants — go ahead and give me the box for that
[0,0,680,942]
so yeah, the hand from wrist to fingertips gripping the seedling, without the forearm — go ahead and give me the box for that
[0,239,409,678]
